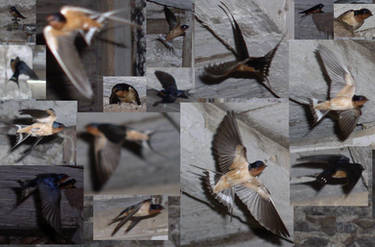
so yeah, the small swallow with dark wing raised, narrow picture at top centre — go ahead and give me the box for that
[158,6,189,49]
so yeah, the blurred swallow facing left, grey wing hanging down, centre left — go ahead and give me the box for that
[86,123,159,189]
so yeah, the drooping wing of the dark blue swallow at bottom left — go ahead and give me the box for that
[38,183,61,233]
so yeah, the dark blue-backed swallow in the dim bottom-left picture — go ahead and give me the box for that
[15,173,76,235]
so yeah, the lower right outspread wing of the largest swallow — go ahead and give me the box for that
[235,181,290,237]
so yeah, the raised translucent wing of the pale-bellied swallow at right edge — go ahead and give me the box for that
[317,45,355,99]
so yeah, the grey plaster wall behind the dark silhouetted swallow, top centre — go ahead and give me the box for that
[194,0,289,98]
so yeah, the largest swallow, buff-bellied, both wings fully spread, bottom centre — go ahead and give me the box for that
[191,112,290,237]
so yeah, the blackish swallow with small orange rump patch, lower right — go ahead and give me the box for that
[294,154,364,195]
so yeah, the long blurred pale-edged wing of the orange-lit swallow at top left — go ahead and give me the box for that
[43,26,93,98]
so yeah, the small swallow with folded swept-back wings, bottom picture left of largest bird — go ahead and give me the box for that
[108,199,164,236]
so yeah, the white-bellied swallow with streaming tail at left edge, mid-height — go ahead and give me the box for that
[7,109,65,162]
